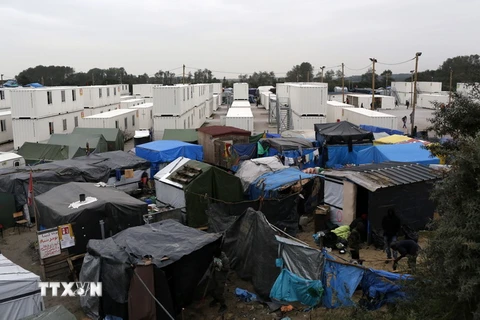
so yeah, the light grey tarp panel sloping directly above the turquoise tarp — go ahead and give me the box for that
[276,236,325,280]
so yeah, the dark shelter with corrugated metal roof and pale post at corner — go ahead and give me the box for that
[323,162,440,234]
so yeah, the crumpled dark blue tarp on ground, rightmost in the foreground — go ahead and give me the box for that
[361,269,412,310]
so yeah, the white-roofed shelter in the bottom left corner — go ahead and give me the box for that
[0,254,44,320]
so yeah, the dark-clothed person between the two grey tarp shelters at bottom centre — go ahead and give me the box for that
[210,248,230,313]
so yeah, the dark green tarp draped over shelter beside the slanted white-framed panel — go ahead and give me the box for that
[176,160,244,228]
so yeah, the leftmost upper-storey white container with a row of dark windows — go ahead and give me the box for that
[10,87,84,119]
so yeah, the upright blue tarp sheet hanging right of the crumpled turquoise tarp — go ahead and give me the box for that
[323,257,364,308]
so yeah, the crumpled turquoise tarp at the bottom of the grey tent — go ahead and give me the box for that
[270,269,323,307]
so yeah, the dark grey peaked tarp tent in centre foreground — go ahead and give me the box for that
[217,208,280,299]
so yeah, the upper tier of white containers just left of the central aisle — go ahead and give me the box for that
[153,84,213,116]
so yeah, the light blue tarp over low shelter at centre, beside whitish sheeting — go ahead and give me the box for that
[248,168,316,200]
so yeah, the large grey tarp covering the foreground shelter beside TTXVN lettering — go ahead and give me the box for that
[80,220,221,319]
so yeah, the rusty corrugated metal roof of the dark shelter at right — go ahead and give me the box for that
[324,162,441,192]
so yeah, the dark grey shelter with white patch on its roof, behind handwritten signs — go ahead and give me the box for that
[35,182,148,254]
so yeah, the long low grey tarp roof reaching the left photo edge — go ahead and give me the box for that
[0,159,110,209]
